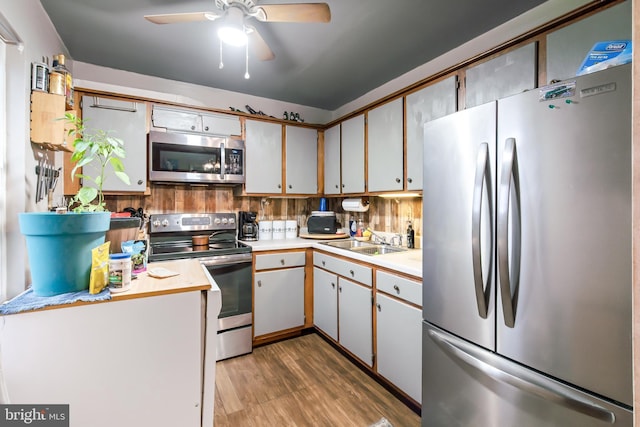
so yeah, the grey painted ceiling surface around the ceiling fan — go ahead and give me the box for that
[40,0,545,111]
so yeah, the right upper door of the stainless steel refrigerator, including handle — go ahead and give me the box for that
[496,65,633,406]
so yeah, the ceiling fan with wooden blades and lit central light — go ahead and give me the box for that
[144,0,331,61]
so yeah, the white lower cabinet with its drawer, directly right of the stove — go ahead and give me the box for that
[253,252,305,337]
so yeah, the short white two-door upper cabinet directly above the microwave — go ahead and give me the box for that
[151,105,242,136]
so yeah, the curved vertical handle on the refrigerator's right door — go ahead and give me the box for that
[497,138,520,328]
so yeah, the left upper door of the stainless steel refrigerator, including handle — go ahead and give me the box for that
[422,102,496,349]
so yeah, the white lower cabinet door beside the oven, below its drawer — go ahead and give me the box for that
[253,267,304,337]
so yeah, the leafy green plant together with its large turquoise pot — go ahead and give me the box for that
[19,112,129,296]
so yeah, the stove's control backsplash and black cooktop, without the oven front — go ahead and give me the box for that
[149,213,251,262]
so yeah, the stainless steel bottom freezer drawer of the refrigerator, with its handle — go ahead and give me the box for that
[422,322,633,427]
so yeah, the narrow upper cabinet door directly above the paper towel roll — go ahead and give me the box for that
[341,114,365,193]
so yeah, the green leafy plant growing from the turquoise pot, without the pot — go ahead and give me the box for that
[63,112,131,212]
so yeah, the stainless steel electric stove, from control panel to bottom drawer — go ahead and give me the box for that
[149,213,253,360]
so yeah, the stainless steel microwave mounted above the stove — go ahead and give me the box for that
[149,131,245,184]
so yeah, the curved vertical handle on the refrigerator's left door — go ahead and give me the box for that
[471,142,493,319]
